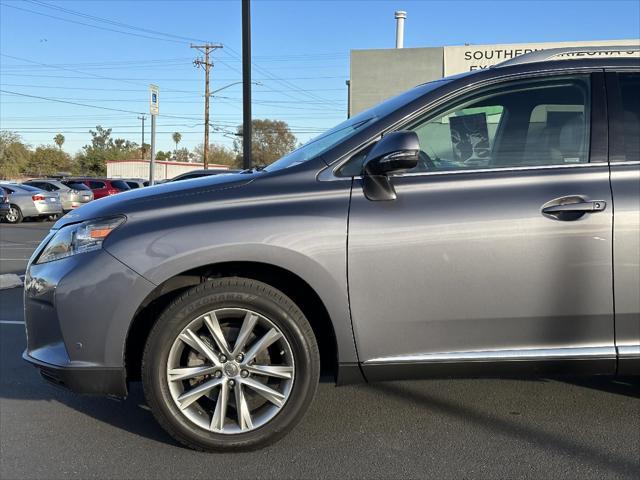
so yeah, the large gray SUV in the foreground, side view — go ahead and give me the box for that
[24,47,640,451]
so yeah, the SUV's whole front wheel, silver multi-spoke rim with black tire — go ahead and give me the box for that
[142,277,320,451]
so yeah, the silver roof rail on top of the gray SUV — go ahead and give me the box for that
[494,42,640,68]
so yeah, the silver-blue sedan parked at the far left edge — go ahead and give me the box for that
[0,183,63,223]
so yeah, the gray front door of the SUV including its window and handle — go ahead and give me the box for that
[348,74,615,373]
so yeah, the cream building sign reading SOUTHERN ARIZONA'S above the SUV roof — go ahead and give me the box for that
[444,39,638,77]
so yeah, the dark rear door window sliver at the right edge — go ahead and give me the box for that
[618,72,640,161]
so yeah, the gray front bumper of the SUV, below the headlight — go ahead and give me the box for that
[23,244,155,396]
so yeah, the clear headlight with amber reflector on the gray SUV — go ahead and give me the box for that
[36,217,125,264]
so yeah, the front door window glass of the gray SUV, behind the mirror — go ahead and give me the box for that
[405,75,590,175]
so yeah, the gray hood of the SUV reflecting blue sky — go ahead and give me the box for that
[53,173,257,229]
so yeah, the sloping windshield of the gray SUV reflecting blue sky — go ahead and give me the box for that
[264,80,445,172]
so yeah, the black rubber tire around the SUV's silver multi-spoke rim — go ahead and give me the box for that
[142,277,320,451]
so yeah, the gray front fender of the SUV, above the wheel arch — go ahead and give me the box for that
[105,179,357,363]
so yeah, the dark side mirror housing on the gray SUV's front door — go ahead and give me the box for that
[364,130,420,175]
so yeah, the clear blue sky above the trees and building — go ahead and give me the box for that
[0,0,640,153]
